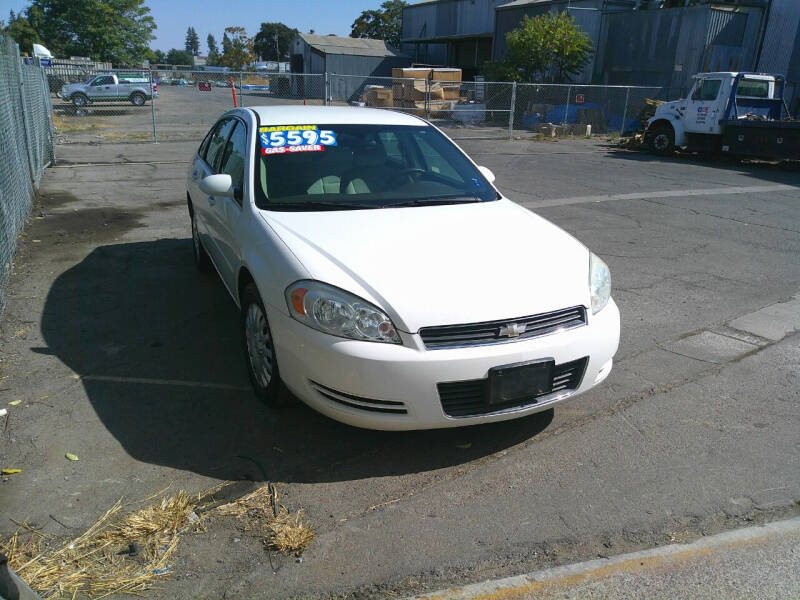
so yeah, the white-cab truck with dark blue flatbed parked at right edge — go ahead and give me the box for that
[645,72,800,160]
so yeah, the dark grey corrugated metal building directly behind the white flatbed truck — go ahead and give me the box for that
[593,0,766,96]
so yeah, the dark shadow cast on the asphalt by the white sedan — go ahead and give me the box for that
[37,239,553,482]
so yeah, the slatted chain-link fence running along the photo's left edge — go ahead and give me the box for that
[0,35,55,309]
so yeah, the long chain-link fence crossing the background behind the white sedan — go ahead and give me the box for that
[47,63,674,143]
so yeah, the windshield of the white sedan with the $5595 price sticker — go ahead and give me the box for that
[255,124,498,211]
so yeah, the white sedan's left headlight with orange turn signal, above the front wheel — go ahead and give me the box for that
[286,281,402,344]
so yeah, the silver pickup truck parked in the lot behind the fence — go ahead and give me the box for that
[57,73,158,107]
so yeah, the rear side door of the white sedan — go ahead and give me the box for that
[189,117,236,274]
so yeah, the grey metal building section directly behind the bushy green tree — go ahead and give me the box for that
[492,0,636,83]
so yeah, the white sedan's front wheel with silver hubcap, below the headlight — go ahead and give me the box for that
[240,283,289,408]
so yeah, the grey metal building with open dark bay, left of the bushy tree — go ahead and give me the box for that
[400,0,508,79]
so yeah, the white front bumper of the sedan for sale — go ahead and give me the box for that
[268,300,620,430]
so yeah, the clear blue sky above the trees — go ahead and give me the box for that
[0,0,382,54]
